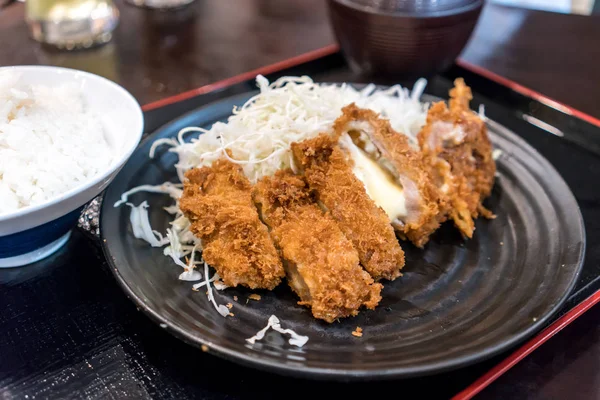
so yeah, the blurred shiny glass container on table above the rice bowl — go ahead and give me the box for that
[25,0,119,50]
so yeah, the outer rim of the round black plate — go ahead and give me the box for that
[99,88,587,381]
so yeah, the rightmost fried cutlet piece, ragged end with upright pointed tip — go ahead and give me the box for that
[418,78,496,238]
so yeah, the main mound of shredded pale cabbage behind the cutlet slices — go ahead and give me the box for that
[151,75,428,182]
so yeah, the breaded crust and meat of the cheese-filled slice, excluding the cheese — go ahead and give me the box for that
[333,104,446,247]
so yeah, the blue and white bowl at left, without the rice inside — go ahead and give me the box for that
[0,66,144,267]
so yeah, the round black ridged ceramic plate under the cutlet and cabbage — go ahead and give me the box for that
[101,90,585,379]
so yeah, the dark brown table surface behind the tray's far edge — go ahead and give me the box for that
[0,0,600,117]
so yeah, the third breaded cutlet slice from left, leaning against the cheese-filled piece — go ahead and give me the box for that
[292,134,404,279]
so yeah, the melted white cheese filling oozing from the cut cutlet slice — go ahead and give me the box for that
[342,135,407,221]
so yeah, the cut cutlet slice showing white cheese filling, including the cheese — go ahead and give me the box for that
[333,104,445,247]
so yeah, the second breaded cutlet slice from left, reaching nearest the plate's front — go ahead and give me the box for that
[254,170,382,322]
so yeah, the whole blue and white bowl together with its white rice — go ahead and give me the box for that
[0,66,144,267]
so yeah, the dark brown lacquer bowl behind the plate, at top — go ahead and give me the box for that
[327,0,484,79]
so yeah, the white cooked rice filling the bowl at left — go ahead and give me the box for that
[0,71,112,214]
